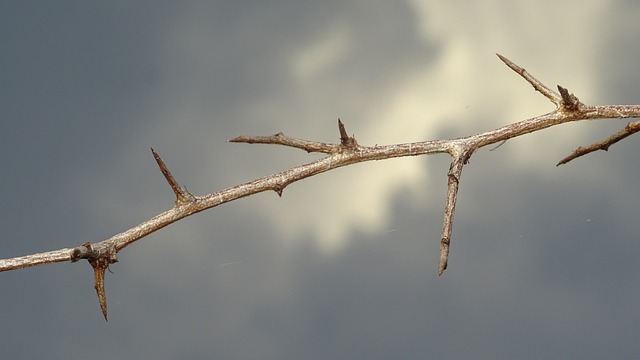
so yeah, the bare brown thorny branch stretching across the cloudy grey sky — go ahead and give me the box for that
[0,54,640,320]
